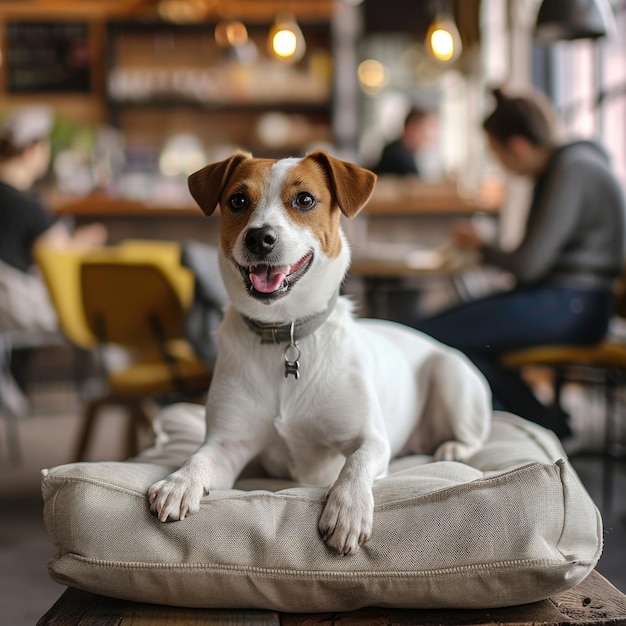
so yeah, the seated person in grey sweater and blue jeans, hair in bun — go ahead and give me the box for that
[413,89,626,439]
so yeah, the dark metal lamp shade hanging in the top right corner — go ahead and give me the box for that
[535,0,615,43]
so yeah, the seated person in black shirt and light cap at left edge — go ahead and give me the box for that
[0,105,107,408]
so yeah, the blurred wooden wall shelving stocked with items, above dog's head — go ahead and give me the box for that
[106,19,334,156]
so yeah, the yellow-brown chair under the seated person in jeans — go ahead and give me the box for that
[501,277,626,512]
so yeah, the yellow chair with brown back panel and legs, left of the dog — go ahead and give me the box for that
[37,242,211,460]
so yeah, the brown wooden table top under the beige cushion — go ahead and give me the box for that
[37,571,626,626]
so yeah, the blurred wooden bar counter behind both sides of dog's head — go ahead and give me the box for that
[47,177,502,254]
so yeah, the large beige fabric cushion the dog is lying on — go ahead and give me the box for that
[43,404,602,612]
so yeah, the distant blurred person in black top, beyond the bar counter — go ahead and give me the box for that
[372,106,437,176]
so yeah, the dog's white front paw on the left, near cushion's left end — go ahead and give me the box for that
[148,470,205,522]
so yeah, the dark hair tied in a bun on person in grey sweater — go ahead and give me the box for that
[483,88,557,146]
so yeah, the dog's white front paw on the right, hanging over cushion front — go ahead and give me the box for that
[319,483,374,556]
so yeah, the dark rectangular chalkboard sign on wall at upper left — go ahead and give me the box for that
[6,22,91,94]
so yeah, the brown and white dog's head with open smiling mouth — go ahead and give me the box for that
[189,151,376,321]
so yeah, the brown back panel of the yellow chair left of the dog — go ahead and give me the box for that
[80,259,185,349]
